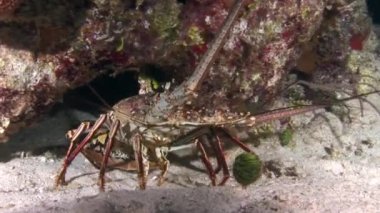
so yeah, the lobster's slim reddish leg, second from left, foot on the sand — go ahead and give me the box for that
[98,120,120,191]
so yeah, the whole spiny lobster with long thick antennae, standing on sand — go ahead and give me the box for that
[55,0,378,191]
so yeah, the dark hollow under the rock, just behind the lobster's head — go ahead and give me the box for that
[63,64,171,114]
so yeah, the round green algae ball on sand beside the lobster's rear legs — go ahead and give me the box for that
[233,153,262,186]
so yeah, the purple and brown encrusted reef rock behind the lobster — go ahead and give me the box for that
[0,0,374,141]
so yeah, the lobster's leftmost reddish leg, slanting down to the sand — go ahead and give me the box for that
[55,114,107,187]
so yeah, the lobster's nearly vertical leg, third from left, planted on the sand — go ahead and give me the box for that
[132,134,149,189]
